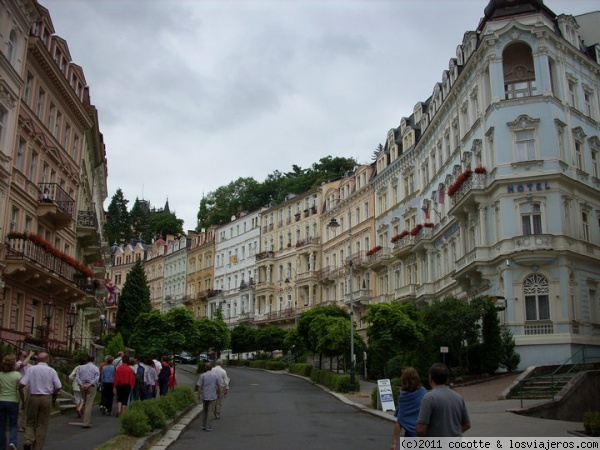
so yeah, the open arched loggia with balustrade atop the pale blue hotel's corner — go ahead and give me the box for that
[502,42,536,100]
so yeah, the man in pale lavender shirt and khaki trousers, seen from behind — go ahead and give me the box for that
[19,352,62,450]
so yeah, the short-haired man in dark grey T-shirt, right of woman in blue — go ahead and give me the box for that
[417,363,471,437]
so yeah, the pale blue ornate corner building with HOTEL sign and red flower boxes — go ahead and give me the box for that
[373,0,600,367]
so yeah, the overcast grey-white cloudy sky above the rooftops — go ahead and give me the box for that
[39,0,600,230]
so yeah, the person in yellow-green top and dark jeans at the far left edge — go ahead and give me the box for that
[0,355,21,450]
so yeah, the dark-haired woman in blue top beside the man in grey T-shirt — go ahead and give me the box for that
[392,367,427,450]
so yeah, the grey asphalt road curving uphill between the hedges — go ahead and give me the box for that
[169,367,393,450]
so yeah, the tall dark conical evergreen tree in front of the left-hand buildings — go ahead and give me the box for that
[115,260,152,346]
